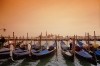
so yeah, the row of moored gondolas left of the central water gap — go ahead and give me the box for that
[0,42,56,60]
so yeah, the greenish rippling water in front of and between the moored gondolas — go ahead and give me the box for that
[0,41,100,66]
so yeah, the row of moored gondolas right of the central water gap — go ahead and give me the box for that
[60,35,100,65]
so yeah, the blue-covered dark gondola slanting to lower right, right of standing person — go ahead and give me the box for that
[75,41,97,65]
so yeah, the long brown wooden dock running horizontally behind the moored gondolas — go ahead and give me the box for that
[0,36,100,41]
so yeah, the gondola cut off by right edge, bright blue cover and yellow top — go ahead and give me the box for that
[81,31,100,61]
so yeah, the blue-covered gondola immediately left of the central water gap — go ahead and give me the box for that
[31,42,56,59]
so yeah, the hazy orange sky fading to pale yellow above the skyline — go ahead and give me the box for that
[0,0,100,36]
